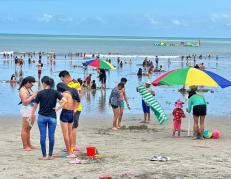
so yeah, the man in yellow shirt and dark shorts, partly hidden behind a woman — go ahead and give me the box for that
[59,70,83,150]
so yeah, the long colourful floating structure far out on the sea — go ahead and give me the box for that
[154,40,201,47]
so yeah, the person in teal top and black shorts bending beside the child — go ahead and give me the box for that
[187,86,207,139]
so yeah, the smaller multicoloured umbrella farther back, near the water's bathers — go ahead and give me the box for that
[84,59,116,70]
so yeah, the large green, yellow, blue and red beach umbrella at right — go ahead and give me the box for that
[152,67,231,88]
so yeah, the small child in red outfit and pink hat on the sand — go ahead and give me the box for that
[172,100,185,137]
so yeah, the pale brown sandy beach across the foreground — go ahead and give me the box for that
[0,115,231,179]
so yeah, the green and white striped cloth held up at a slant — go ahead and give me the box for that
[137,85,168,124]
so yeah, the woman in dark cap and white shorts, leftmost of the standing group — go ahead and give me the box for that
[18,76,38,151]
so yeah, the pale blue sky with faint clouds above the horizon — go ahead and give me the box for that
[0,0,231,38]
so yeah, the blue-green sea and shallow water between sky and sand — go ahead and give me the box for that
[0,34,231,115]
